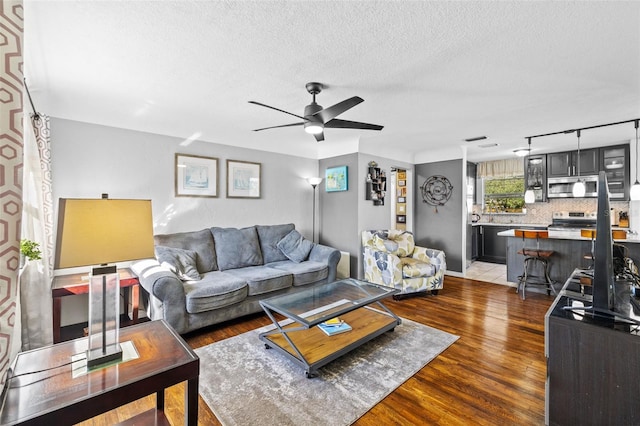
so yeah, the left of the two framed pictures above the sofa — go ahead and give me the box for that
[175,154,218,197]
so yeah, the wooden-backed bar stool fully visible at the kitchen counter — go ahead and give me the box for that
[513,229,557,300]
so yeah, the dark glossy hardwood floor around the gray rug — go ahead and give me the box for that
[77,276,553,426]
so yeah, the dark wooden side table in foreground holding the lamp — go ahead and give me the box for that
[0,320,200,425]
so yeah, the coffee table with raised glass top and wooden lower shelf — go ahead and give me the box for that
[260,278,401,378]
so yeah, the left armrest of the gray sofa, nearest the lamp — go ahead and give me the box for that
[131,259,187,333]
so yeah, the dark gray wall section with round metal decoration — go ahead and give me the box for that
[414,160,466,273]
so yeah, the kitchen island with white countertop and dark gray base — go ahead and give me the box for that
[498,227,640,290]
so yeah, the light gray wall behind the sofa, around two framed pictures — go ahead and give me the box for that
[51,118,318,235]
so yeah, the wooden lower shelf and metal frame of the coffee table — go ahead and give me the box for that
[260,282,402,378]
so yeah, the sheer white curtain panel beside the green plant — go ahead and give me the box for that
[19,114,54,350]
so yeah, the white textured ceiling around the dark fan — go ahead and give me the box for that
[24,0,640,162]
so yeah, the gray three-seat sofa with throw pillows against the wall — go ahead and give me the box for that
[132,224,340,333]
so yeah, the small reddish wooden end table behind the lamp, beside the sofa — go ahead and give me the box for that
[51,268,140,343]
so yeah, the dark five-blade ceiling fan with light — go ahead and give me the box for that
[249,82,383,142]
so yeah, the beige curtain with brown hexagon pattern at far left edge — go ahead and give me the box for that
[0,0,24,384]
